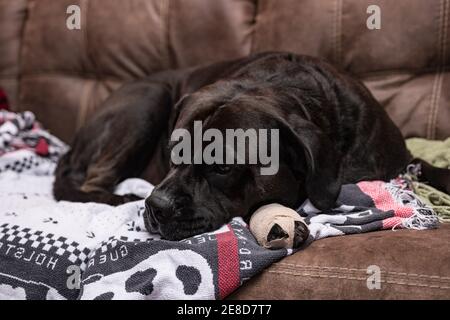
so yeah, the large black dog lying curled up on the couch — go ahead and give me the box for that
[54,53,450,240]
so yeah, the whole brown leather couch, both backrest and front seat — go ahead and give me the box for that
[0,0,450,299]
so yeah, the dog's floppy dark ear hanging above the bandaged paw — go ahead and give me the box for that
[281,115,341,210]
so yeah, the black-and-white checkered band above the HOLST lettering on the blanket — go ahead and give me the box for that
[0,223,91,269]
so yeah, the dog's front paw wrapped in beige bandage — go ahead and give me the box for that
[250,203,309,249]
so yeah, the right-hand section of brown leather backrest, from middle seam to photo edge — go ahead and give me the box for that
[253,0,450,139]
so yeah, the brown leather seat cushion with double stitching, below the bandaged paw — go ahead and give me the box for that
[229,224,450,299]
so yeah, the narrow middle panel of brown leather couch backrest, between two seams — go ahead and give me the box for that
[169,0,256,68]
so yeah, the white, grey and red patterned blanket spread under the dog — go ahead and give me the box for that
[0,111,437,299]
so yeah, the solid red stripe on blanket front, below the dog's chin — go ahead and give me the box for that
[216,226,240,299]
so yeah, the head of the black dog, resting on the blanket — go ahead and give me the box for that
[145,81,340,240]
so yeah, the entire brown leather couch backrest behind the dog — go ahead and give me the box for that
[0,0,450,141]
